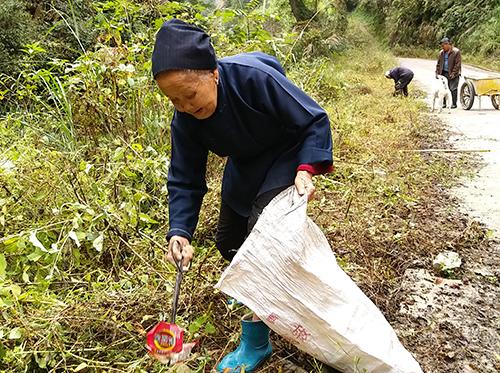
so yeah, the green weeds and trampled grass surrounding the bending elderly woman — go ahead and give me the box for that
[0,0,492,372]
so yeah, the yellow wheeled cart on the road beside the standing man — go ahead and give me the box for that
[460,75,500,110]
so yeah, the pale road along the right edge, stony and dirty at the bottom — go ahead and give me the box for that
[395,58,500,373]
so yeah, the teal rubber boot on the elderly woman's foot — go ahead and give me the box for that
[217,318,273,373]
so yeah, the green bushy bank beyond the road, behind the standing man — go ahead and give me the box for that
[356,0,500,71]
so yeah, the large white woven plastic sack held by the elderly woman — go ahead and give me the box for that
[216,186,422,373]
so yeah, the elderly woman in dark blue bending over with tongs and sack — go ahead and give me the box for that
[152,19,332,372]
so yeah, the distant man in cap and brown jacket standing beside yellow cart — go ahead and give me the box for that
[436,38,462,109]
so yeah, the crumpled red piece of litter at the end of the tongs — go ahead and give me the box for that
[146,321,184,356]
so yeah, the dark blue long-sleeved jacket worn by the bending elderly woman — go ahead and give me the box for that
[167,52,332,239]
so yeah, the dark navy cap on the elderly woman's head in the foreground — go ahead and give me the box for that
[152,18,217,77]
